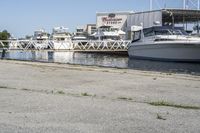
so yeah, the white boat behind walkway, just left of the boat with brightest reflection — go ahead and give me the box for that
[33,29,49,49]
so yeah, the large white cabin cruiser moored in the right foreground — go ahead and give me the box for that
[128,26,200,62]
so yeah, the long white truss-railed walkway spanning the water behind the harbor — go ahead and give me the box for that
[0,40,131,51]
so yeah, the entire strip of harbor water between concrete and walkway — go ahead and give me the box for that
[0,51,200,75]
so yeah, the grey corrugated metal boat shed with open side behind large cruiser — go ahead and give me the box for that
[126,9,200,39]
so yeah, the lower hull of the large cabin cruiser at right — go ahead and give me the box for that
[128,43,200,62]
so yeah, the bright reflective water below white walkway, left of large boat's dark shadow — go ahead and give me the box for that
[6,51,128,68]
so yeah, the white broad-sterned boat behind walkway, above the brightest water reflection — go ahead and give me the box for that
[51,27,72,49]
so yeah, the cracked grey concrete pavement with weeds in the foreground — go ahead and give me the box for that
[0,60,200,133]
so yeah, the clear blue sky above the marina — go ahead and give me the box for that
[0,0,182,37]
